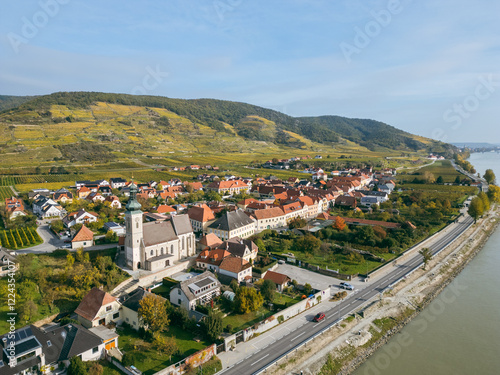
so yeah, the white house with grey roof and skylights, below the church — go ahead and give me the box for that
[170,271,221,310]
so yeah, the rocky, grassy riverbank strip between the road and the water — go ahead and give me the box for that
[272,207,499,375]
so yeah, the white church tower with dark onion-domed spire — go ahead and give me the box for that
[125,183,144,271]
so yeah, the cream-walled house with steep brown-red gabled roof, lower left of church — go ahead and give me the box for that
[75,287,121,328]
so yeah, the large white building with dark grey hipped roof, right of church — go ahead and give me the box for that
[206,210,255,240]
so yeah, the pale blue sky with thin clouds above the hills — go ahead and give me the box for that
[0,0,500,143]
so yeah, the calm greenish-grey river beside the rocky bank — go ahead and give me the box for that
[354,153,500,375]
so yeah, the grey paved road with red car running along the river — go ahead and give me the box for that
[220,216,474,375]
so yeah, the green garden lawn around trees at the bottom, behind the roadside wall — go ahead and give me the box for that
[117,326,211,375]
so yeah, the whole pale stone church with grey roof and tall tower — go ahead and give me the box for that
[125,184,196,272]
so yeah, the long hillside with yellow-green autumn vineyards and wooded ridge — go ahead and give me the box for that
[0,92,452,165]
